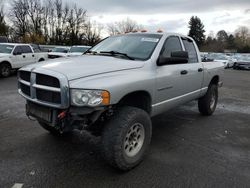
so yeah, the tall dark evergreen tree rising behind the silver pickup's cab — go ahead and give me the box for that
[188,16,205,47]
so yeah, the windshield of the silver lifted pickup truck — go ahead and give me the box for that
[89,34,162,60]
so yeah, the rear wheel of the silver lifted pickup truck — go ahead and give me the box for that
[198,84,218,116]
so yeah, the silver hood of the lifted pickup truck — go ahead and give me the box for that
[24,55,144,81]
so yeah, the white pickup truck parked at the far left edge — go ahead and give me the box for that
[0,43,47,77]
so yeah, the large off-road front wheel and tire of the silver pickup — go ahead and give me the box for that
[102,106,152,171]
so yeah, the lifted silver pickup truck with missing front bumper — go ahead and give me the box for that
[18,33,224,170]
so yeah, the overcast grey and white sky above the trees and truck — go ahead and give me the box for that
[70,0,250,34]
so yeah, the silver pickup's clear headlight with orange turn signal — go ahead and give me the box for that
[70,89,110,107]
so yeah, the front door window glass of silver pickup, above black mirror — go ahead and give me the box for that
[161,36,182,57]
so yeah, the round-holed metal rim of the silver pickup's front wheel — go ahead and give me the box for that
[123,123,145,157]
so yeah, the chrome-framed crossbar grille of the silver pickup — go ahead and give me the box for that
[18,70,68,108]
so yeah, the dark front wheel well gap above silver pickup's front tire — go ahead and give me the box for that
[118,91,151,114]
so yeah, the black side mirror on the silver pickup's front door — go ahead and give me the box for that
[157,51,188,66]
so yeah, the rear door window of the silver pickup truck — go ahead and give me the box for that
[182,38,198,63]
